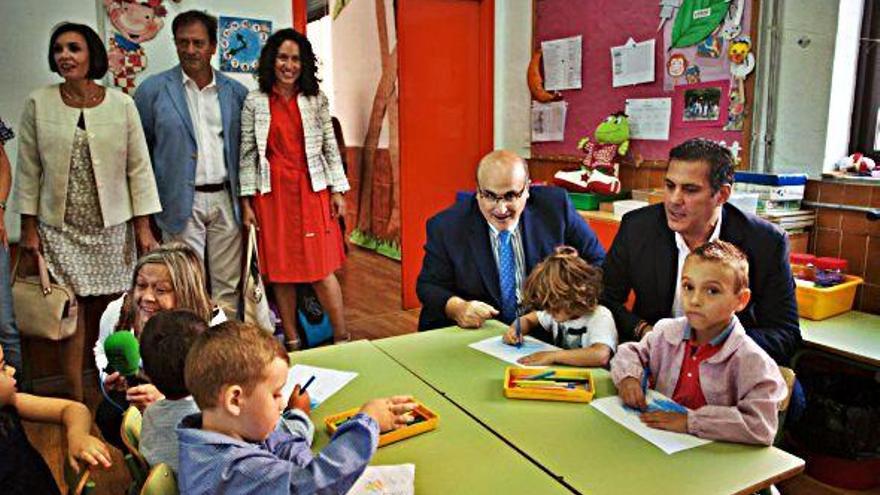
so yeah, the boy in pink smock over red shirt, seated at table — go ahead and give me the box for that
[611,241,786,445]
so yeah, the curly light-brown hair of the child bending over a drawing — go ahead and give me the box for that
[523,246,602,316]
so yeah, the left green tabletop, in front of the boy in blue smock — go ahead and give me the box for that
[291,341,570,494]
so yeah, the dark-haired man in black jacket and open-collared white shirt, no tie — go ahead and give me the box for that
[602,139,801,365]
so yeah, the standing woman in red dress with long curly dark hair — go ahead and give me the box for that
[239,29,349,347]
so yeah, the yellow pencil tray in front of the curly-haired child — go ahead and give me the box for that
[504,366,596,402]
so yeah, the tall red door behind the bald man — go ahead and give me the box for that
[397,0,495,308]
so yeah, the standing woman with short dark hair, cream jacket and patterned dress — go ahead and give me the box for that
[15,23,161,400]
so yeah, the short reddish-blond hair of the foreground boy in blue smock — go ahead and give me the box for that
[184,321,288,410]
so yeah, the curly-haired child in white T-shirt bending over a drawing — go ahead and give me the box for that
[504,246,617,367]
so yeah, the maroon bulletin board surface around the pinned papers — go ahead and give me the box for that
[532,0,760,167]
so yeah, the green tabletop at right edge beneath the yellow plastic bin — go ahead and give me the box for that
[800,311,880,368]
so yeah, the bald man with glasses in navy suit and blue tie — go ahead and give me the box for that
[416,150,605,330]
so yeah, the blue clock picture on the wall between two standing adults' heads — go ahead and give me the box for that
[218,17,272,73]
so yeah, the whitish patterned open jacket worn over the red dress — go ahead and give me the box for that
[238,89,350,196]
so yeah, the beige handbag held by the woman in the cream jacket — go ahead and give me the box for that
[12,251,78,340]
